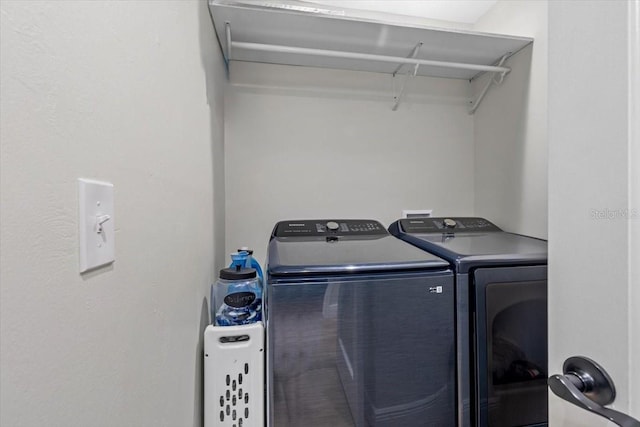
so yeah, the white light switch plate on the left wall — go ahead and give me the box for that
[78,178,115,273]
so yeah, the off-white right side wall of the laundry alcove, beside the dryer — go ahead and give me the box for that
[473,0,548,239]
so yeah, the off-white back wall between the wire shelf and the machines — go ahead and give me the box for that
[225,62,474,266]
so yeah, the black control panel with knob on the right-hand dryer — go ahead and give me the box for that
[400,217,502,233]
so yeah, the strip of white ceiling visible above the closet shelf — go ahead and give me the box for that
[306,0,497,24]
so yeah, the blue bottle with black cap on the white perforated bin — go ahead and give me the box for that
[211,262,262,326]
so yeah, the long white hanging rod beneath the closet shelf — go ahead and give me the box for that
[227,40,511,73]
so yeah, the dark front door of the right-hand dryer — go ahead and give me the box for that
[474,266,548,427]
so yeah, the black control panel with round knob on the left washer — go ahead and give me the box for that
[273,219,388,237]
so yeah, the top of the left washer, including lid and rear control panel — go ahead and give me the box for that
[267,220,449,276]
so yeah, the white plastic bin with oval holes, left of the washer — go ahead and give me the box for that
[204,323,264,427]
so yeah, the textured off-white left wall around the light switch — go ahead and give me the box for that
[0,0,225,427]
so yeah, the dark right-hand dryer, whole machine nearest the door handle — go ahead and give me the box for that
[389,217,548,427]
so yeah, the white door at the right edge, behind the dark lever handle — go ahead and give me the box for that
[548,0,640,427]
